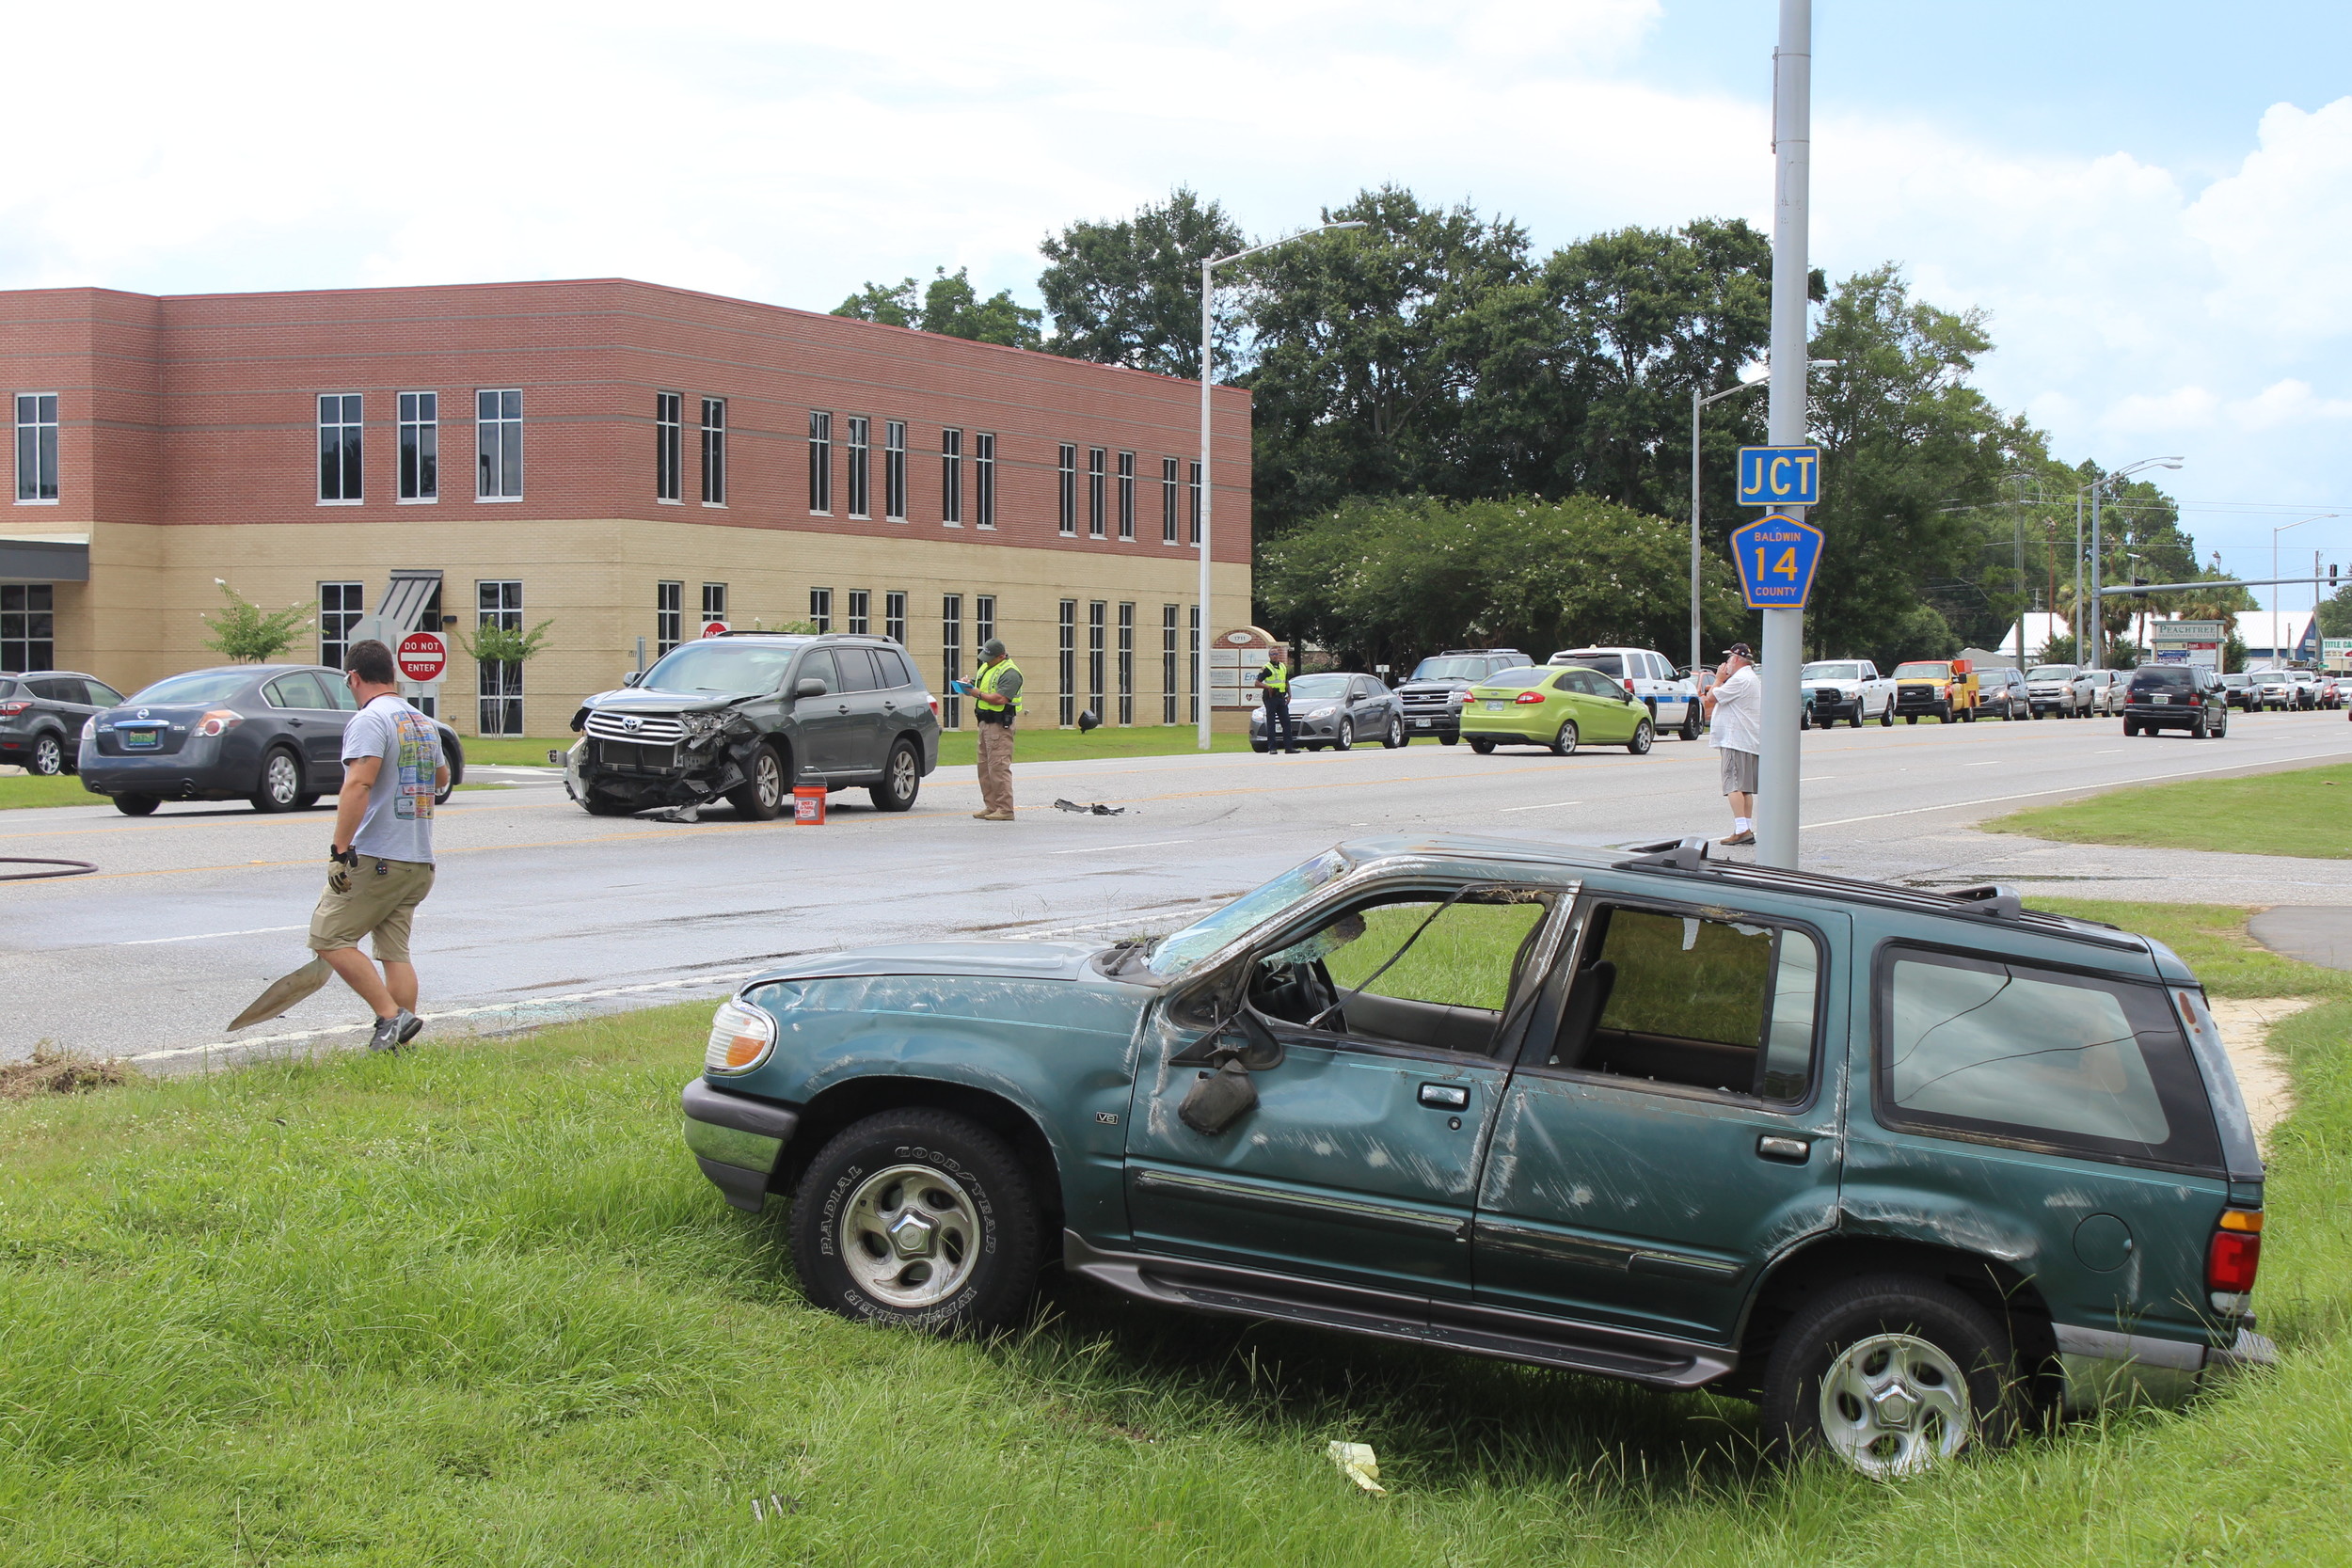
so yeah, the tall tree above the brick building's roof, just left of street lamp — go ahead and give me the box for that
[1038,185,1249,378]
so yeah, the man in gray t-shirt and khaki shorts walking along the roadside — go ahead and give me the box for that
[310,640,450,1051]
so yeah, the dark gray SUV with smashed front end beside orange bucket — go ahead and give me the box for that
[564,632,939,818]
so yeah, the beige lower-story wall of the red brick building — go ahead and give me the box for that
[56,508,1249,736]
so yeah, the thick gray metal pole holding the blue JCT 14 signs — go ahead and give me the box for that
[1757,0,1814,867]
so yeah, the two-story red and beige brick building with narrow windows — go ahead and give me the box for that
[0,277,1249,736]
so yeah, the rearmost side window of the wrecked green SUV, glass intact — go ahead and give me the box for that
[1877,950,2220,1168]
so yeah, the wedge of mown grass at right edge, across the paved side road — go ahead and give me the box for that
[1980,762,2352,861]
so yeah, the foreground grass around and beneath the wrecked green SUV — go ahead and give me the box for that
[0,905,2352,1568]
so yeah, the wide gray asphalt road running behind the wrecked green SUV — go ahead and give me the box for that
[0,712,2352,1069]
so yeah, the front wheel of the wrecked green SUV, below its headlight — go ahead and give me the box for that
[790,1110,1044,1333]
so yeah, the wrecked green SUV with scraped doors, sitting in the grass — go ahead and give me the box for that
[685,837,2272,1477]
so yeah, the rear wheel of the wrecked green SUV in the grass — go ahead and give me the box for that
[1759,1275,2023,1479]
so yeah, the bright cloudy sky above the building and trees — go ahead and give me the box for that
[18,0,2352,604]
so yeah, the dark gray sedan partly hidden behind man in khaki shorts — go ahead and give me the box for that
[80,665,466,816]
